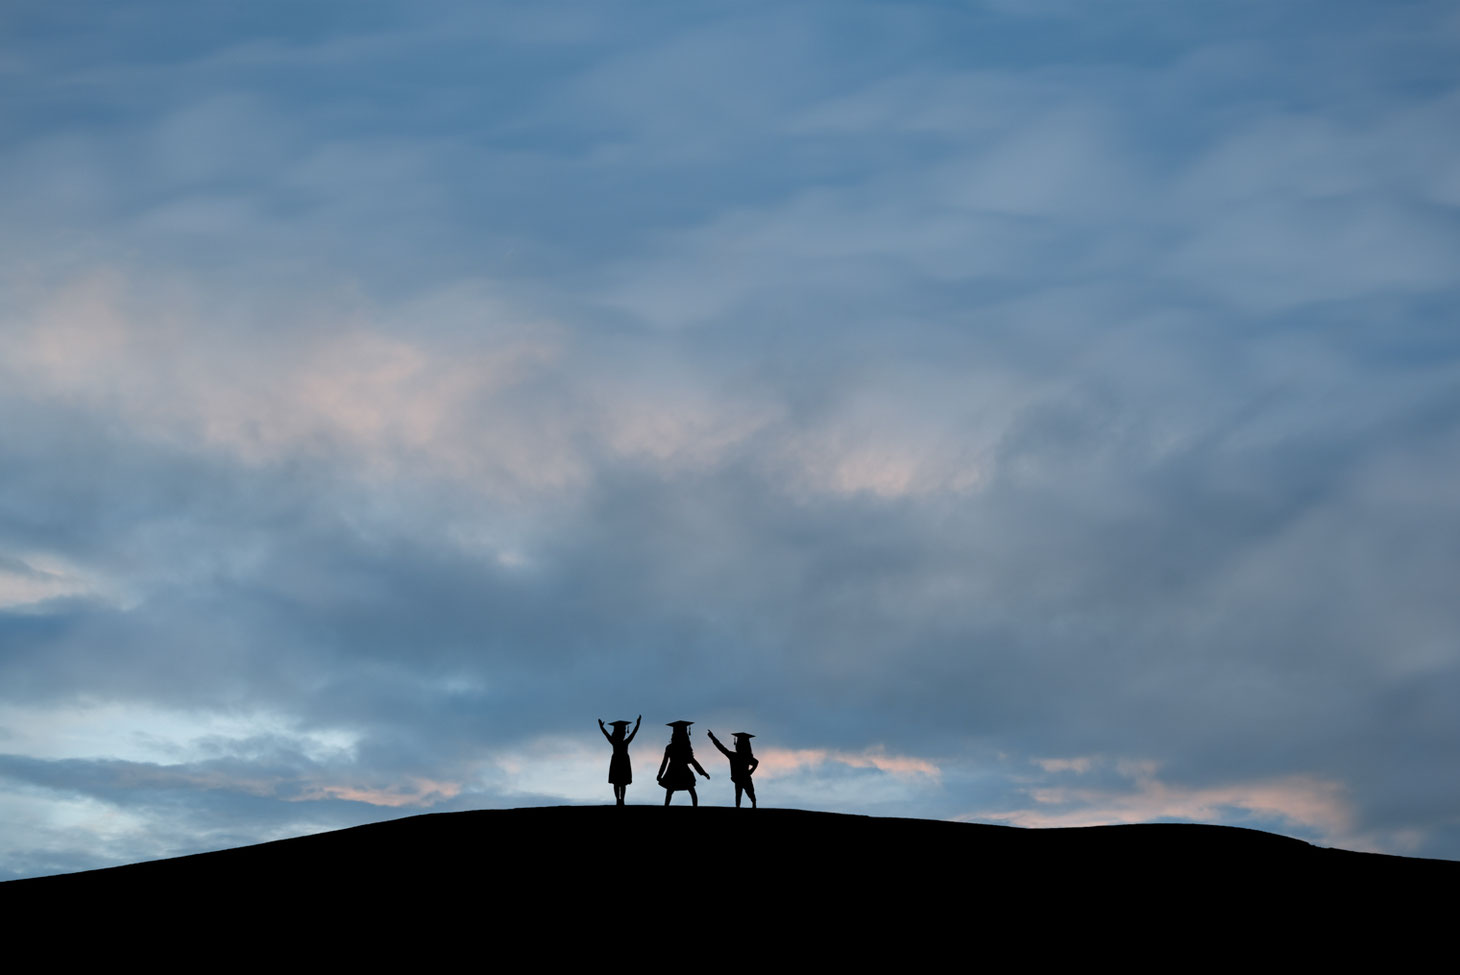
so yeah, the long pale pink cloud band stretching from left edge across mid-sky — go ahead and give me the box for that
[0,269,999,507]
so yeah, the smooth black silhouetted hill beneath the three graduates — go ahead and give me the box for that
[0,806,1460,971]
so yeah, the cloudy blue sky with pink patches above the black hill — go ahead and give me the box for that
[0,0,1460,877]
